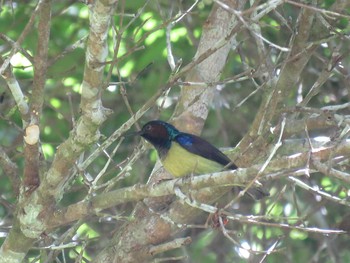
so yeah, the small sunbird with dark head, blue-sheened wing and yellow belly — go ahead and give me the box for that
[136,120,269,200]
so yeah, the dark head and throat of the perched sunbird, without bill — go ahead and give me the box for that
[137,120,180,150]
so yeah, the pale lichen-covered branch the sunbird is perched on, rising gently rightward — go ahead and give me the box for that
[49,139,350,228]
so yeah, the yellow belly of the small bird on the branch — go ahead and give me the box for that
[162,142,223,177]
